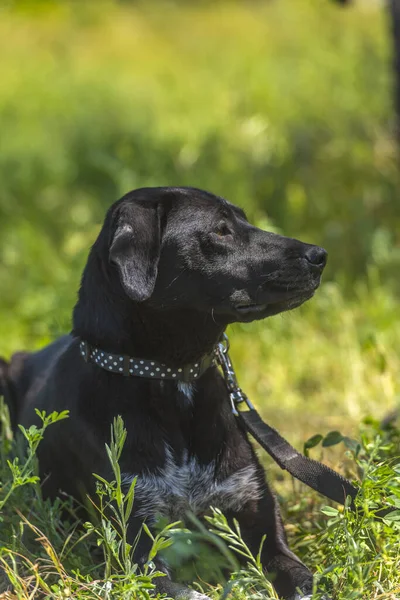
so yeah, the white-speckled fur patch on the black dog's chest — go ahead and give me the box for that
[123,448,260,519]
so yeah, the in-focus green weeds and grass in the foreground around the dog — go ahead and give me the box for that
[0,405,400,600]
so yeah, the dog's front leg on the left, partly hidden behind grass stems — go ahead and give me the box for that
[128,517,210,600]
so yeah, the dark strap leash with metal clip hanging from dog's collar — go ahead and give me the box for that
[216,334,358,506]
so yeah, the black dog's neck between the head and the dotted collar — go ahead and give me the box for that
[73,258,225,366]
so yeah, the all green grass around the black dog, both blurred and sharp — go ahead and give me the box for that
[0,0,400,600]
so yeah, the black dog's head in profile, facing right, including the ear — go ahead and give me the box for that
[99,188,327,324]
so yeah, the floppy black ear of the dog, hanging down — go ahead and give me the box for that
[109,202,161,302]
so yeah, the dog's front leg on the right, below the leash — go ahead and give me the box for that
[227,484,313,600]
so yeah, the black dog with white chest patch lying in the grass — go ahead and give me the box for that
[3,188,326,600]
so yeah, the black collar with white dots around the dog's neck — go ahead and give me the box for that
[79,340,216,383]
